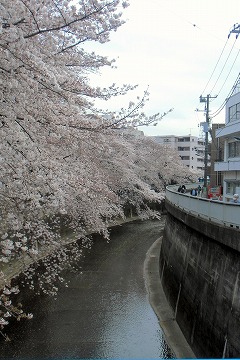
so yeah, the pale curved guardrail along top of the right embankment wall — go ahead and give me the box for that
[166,184,240,229]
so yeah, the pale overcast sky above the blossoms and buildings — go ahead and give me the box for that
[85,0,240,136]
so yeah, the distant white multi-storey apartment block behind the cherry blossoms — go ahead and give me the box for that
[152,135,205,177]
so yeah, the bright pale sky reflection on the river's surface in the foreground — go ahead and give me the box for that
[96,288,171,358]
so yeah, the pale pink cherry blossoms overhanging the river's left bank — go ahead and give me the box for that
[0,0,193,338]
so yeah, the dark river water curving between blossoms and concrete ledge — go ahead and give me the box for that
[0,221,173,359]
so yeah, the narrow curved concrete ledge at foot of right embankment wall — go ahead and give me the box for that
[144,238,196,359]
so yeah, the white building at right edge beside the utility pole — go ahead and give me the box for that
[214,84,240,201]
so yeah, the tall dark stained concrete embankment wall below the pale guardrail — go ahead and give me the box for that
[160,201,240,358]
